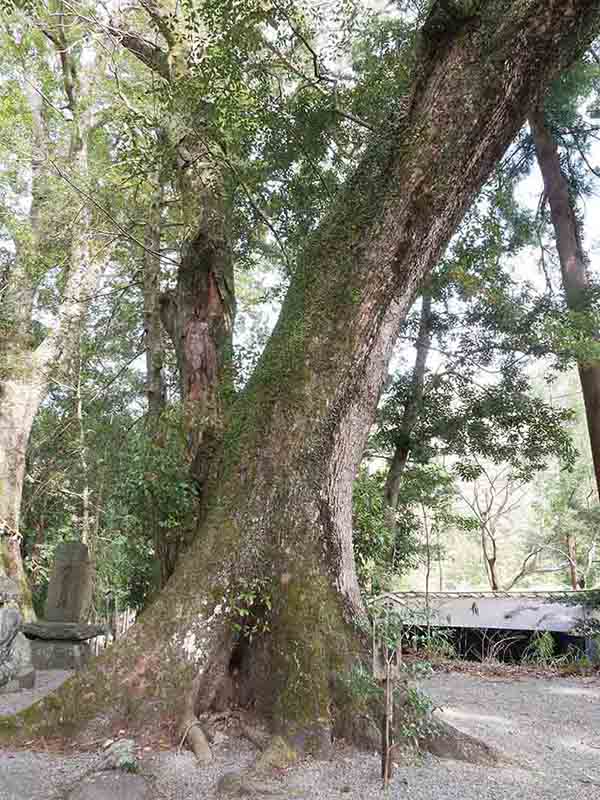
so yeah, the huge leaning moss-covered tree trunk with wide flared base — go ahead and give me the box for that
[8,0,600,748]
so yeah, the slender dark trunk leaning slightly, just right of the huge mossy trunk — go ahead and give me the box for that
[384,291,432,510]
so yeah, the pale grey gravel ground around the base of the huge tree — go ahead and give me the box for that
[0,674,600,800]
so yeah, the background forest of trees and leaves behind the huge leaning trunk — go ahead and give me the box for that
[0,0,600,618]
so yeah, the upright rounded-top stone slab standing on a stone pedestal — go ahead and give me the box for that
[45,542,93,622]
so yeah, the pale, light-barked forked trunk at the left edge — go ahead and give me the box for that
[0,32,101,619]
